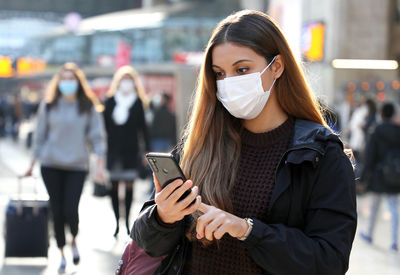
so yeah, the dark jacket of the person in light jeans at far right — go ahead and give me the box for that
[361,122,400,194]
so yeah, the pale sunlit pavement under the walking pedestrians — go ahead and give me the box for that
[0,139,400,275]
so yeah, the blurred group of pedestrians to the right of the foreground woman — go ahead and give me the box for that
[325,93,400,251]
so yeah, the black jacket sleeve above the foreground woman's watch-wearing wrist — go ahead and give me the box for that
[243,143,357,275]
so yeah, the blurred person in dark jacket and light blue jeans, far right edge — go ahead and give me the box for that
[360,103,400,251]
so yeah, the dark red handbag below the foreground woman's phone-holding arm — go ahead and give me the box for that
[115,240,165,275]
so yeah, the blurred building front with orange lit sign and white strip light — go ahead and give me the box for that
[301,0,400,108]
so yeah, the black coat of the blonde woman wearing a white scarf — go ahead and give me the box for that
[103,97,150,169]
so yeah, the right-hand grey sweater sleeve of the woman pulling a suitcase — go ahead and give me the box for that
[87,107,106,160]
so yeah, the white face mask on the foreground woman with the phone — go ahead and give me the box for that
[217,56,276,119]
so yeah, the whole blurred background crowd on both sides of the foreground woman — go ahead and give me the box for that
[0,59,400,269]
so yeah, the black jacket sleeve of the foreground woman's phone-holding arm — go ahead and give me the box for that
[131,200,184,257]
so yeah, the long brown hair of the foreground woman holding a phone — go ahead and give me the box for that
[181,10,326,232]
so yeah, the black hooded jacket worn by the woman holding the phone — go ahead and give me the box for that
[131,119,357,275]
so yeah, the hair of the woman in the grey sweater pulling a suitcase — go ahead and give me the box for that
[45,62,104,114]
